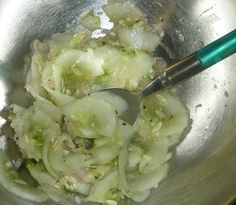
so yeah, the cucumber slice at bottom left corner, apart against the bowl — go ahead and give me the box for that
[0,151,48,203]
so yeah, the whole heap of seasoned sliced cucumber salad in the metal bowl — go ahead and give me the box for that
[0,1,189,205]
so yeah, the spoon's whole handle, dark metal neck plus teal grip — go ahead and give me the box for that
[142,30,236,97]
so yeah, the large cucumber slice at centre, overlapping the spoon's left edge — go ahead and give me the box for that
[62,96,117,137]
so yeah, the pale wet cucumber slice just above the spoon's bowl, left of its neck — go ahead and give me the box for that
[95,46,154,90]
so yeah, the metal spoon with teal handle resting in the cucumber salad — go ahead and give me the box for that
[103,30,236,125]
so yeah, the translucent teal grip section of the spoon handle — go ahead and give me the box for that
[195,30,236,69]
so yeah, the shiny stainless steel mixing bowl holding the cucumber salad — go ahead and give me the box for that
[0,0,236,205]
